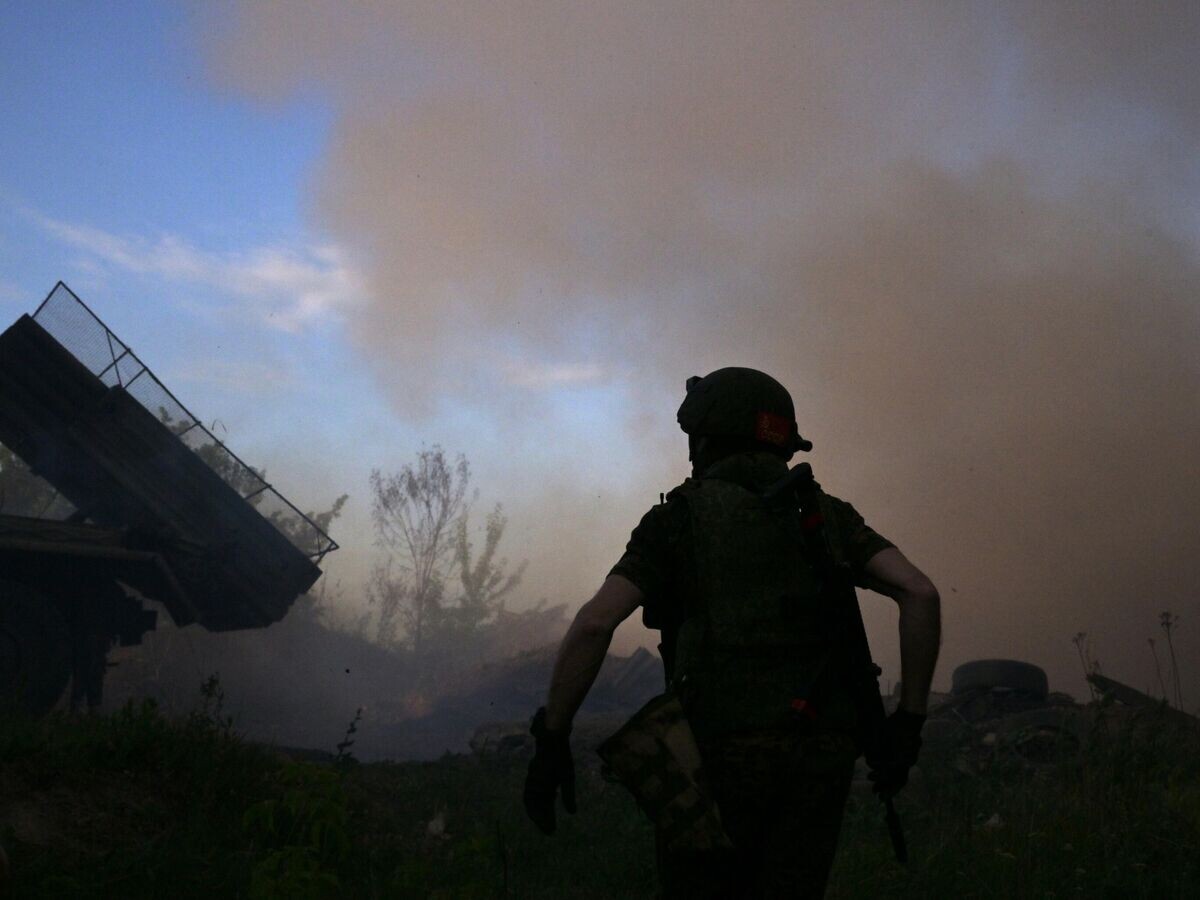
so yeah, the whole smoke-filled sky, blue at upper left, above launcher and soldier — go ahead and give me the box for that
[0,0,1200,706]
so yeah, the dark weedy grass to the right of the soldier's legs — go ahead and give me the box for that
[829,710,1200,899]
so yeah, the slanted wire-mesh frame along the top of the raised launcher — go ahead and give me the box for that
[34,281,337,563]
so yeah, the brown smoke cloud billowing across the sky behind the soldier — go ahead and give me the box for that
[202,0,1200,703]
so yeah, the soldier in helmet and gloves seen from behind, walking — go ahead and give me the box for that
[524,367,941,899]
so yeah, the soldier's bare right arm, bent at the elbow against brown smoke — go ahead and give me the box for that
[863,547,942,715]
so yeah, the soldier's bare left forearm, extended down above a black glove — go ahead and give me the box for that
[546,575,642,731]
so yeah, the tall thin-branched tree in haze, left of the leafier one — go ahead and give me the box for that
[367,444,470,656]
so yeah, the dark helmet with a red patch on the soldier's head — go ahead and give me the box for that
[676,366,812,452]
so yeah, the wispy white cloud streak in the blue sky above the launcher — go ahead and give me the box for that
[29,212,364,331]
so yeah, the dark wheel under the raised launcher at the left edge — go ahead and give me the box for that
[0,580,71,715]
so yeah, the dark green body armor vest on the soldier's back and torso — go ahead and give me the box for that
[671,478,854,739]
